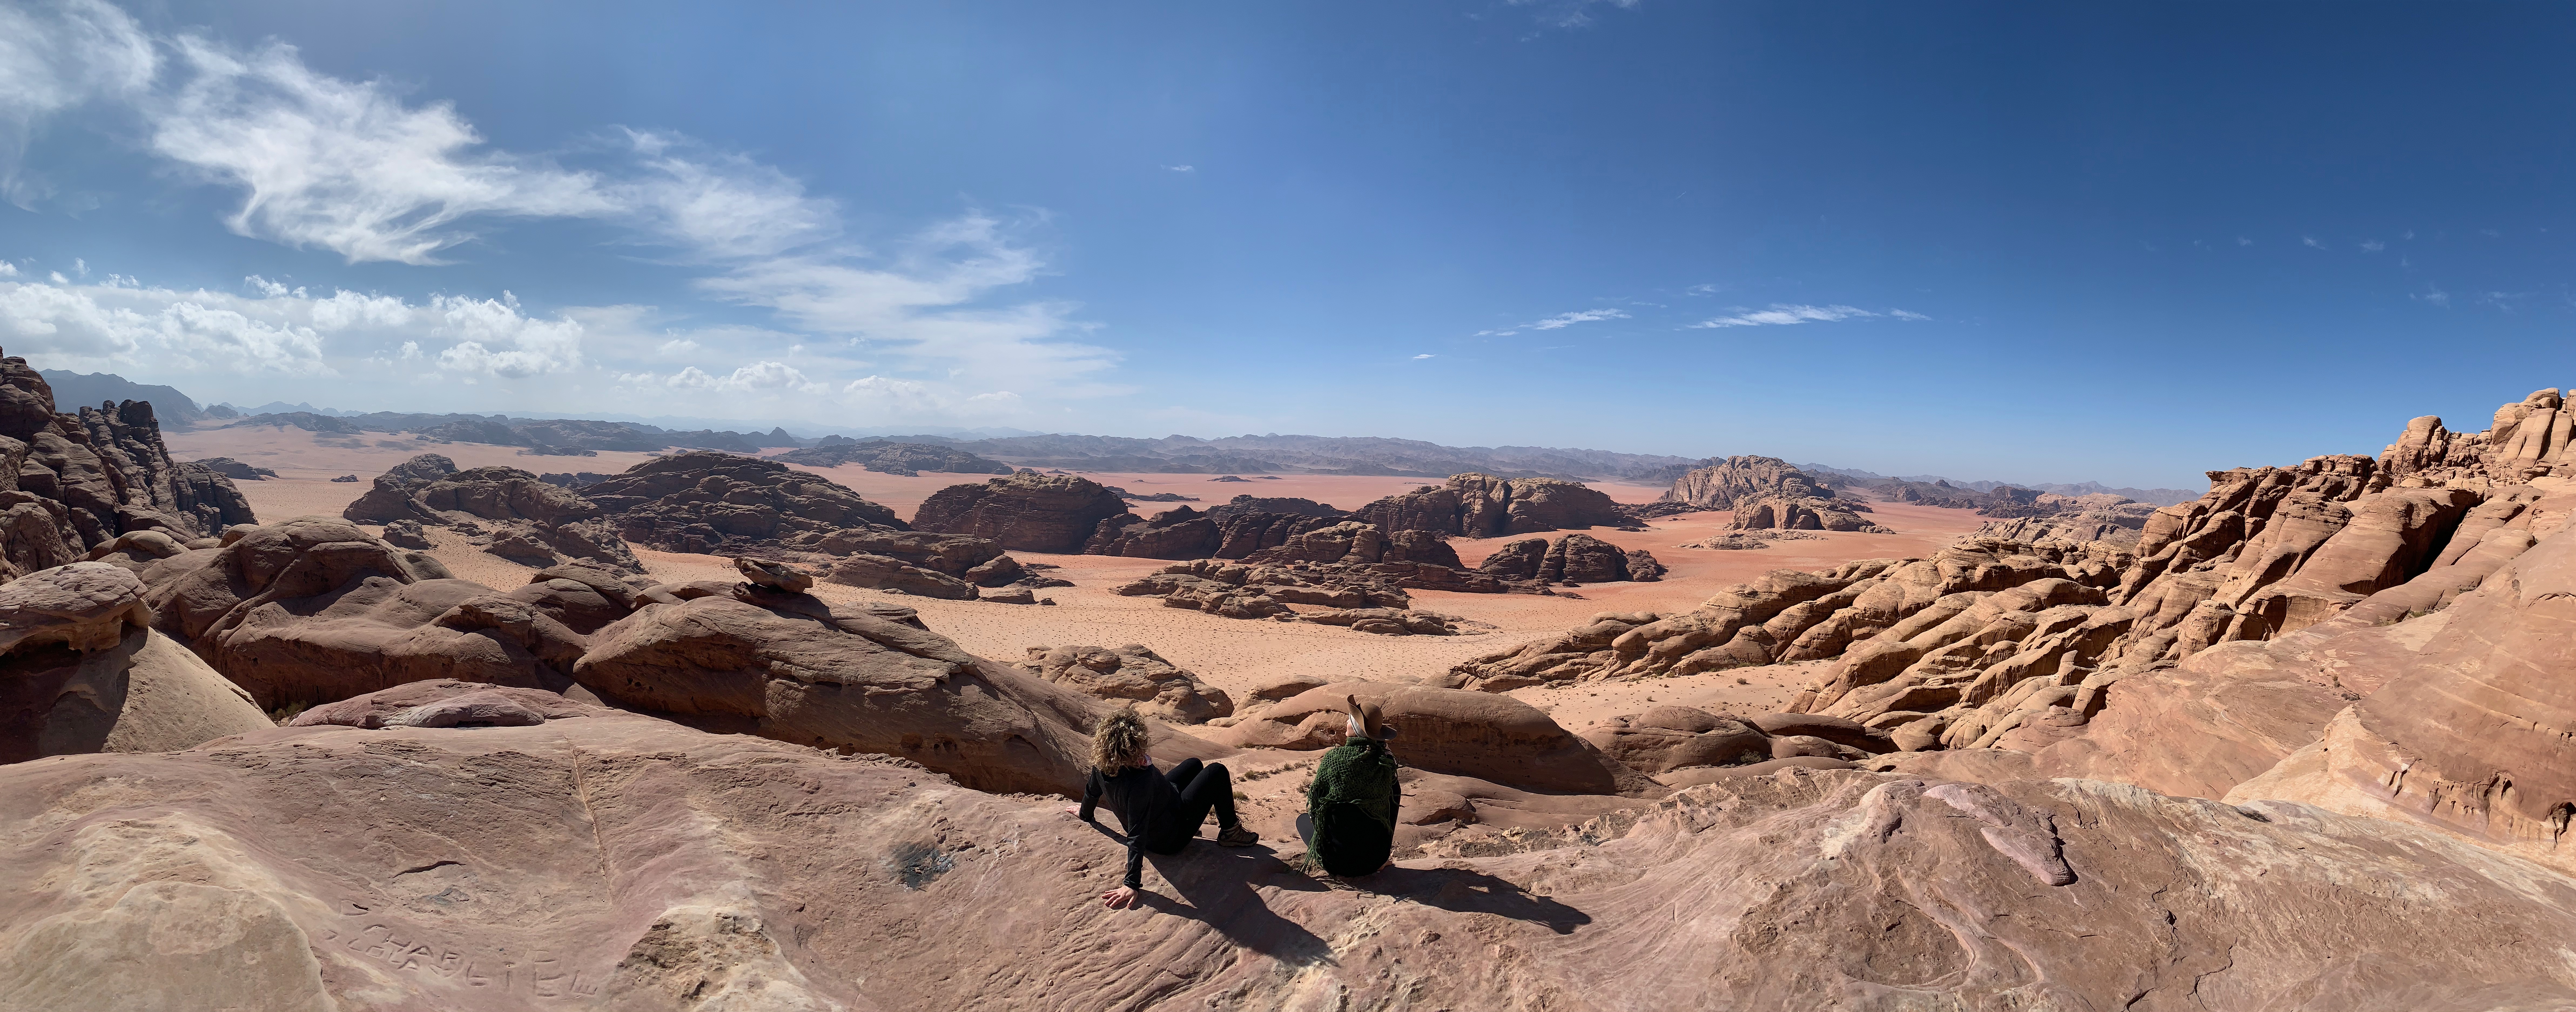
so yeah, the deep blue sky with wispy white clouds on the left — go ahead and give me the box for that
[0,0,2576,487]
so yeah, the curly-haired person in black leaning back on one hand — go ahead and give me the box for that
[1064,706,1262,909]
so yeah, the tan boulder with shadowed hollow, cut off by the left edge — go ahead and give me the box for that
[0,561,270,762]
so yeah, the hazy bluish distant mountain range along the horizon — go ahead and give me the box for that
[44,371,2200,505]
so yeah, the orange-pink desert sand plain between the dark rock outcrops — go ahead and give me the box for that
[165,427,1981,729]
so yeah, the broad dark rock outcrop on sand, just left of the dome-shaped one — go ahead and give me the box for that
[582,451,909,554]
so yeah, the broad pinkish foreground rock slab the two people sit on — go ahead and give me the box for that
[0,726,2576,1012]
